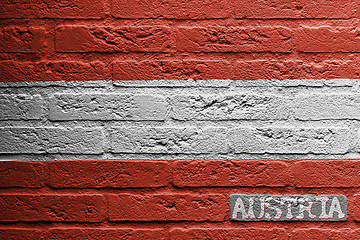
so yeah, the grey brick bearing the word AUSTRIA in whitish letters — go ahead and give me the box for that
[230,194,347,221]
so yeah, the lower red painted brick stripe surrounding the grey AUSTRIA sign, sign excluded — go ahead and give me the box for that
[0,159,360,239]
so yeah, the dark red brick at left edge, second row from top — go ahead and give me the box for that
[0,26,50,53]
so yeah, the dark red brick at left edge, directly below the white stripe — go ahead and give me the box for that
[0,161,48,188]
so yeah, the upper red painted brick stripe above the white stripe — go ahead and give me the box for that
[0,0,360,81]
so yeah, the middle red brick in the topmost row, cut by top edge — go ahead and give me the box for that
[112,0,230,19]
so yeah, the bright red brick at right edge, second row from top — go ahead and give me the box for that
[296,26,360,53]
